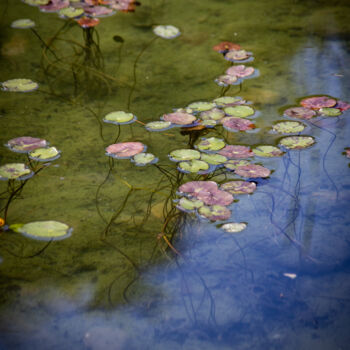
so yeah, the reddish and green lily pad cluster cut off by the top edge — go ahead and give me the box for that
[21,0,139,28]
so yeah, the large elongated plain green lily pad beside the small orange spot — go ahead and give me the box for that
[14,221,73,241]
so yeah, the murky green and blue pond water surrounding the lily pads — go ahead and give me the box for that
[0,0,350,350]
